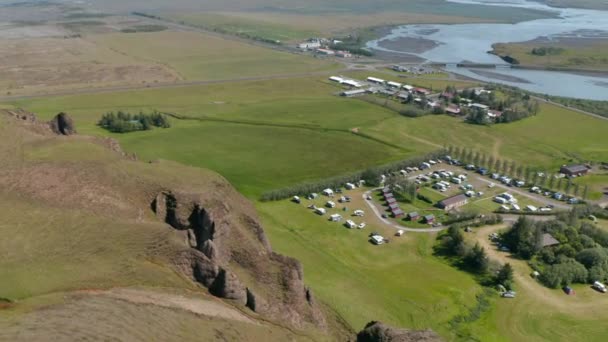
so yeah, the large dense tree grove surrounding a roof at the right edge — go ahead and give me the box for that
[501,212,608,288]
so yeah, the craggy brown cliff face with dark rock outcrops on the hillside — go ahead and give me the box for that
[152,191,326,328]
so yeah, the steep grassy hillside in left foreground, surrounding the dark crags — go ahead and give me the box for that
[0,113,346,340]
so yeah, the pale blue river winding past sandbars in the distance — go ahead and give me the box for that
[367,0,608,100]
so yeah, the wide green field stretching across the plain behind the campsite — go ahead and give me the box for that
[5,77,608,196]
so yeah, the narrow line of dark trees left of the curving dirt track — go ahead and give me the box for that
[437,225,513,290]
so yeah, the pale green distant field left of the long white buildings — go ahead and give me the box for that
[88,31,337,80]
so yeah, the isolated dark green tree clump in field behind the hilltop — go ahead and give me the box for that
[97,110,171,133]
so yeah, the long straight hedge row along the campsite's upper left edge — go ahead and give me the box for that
[260,150,446,201]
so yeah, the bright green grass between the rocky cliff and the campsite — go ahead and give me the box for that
[258,201,480,336]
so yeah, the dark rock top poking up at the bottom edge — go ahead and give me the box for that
[357,321,442,342]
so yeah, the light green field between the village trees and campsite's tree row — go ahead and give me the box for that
[366,104,608,171]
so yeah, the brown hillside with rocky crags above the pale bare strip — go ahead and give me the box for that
[0,111,348,339]
